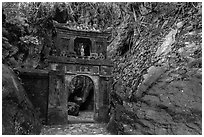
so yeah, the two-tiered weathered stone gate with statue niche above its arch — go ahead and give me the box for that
[48,25,113,124]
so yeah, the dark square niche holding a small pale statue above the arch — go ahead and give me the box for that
[74,38,92,56]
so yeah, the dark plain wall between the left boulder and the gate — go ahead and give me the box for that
[19,70,49,124]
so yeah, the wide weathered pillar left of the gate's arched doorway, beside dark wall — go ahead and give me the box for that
[48,71,68,125]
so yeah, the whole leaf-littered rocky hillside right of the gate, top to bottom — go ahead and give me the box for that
[107,3,202,135]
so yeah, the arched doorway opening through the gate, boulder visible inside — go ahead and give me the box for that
[68,75,95,121]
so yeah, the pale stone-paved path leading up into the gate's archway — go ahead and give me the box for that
[41,112,110,135]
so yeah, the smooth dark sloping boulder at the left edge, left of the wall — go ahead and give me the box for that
[2,64,42,135]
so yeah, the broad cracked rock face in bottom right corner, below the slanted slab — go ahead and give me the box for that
[133,67,202,135]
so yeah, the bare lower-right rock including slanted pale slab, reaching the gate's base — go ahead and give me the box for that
[108,67,202,135]
